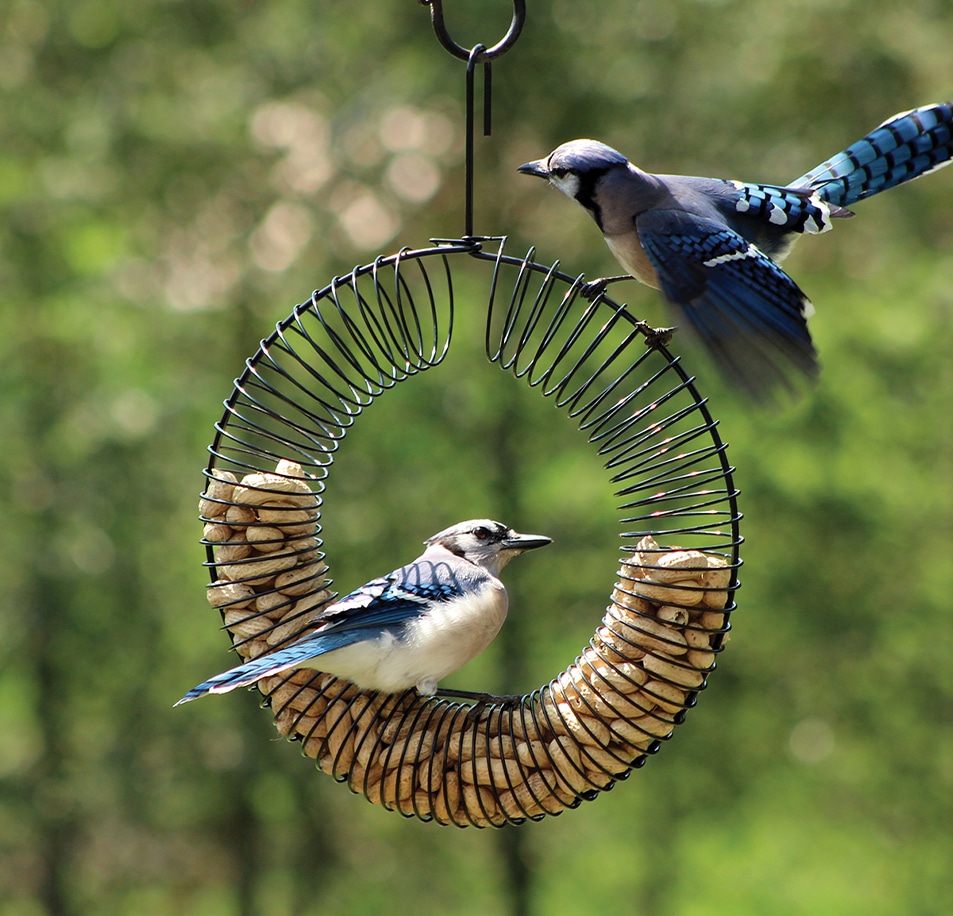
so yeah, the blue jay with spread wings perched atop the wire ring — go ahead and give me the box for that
[519,102,953,398]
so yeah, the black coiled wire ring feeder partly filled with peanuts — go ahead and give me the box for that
[200,238,741,827]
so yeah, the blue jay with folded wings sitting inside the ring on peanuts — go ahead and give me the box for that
[175,519,551,706]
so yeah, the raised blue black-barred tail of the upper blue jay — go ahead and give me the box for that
[790,101,953,207]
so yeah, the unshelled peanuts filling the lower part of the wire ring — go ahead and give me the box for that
[195,461,731,827]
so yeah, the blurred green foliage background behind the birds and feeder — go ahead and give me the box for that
[0,0,953,916]
